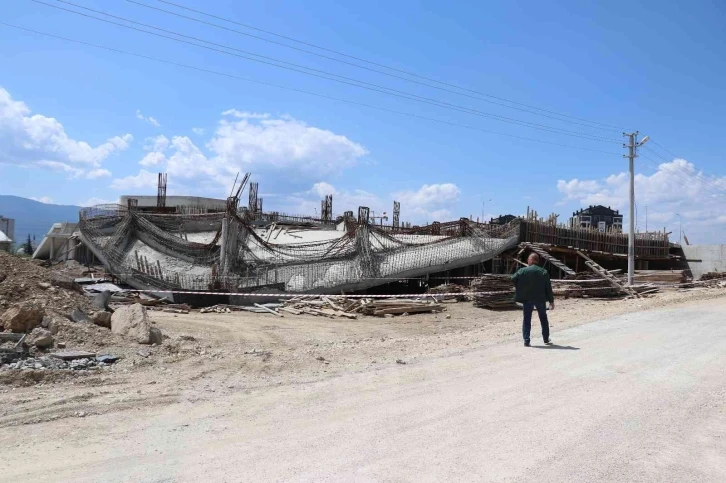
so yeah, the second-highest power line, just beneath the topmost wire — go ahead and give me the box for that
[126,0,620,132]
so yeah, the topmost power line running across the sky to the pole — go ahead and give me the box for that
[149,0,624,131]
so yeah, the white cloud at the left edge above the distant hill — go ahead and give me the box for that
[0,87,133,177]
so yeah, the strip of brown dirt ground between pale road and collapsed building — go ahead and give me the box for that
[0,289,726,430]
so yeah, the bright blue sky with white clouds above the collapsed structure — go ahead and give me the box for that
[0,0,726,243]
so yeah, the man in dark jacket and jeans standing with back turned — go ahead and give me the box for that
[512,253,555,347]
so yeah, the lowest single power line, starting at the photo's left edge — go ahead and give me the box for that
[0,22,620,156]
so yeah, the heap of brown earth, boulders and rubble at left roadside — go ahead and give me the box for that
[0,252,163,378]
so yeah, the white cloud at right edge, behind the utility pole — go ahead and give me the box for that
[557,159,726,243]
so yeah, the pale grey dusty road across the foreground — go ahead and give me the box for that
[0,302,726,483]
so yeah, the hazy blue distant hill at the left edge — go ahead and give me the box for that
[0,195,81,243]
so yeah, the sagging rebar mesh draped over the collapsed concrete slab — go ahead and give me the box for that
[79,205,519,292]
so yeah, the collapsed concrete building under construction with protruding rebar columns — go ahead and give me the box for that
[35,175,678,299]
